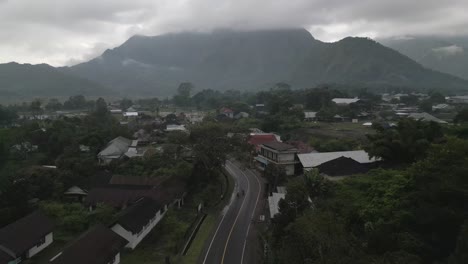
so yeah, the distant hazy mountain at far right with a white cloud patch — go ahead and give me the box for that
[379,37,468,79]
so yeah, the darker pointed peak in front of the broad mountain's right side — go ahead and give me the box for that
[292,37,468,90]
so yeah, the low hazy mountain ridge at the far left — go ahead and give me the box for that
[0,62,110,97]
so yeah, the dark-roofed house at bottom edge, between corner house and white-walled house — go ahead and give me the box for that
[50,224,128,264]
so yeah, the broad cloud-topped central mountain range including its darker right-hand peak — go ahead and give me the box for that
[66,29,468,96]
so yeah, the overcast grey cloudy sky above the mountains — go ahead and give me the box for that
[0,0,468,66]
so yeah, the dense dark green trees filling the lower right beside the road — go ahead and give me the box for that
[269,131,468,263]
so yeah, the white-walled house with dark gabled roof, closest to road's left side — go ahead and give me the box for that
[111,198,167,249]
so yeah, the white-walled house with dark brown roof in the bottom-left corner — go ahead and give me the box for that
[0,211,54,264]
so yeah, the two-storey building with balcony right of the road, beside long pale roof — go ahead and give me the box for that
[255,141,298,175]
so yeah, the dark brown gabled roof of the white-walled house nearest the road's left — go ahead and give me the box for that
[116,198,162,234]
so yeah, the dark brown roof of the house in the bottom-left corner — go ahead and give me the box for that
[0,211,54,256]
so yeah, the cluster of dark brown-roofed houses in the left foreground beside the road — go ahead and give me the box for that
[0,175,185,264]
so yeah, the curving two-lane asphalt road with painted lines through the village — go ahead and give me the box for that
[200,161,263,264]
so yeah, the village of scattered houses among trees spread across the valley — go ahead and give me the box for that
[0,87,468,264]
